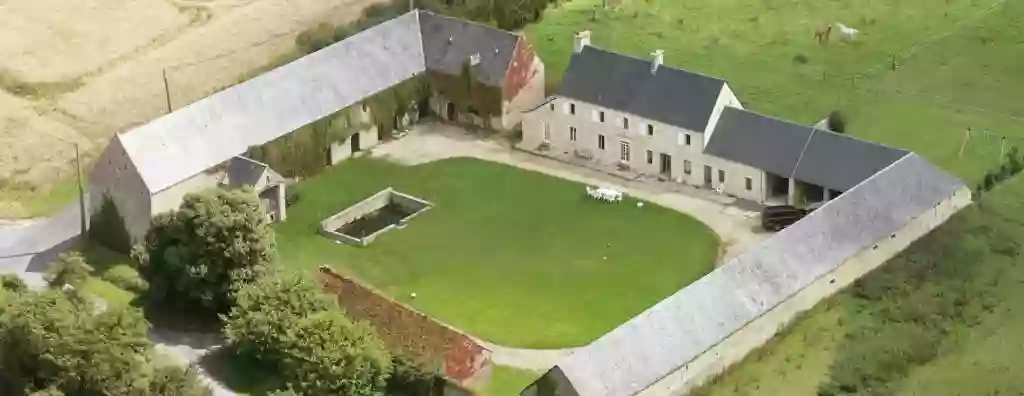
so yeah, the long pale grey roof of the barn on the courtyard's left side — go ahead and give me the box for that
[121,12,425,193]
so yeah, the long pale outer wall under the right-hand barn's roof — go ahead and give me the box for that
[638,187,971,396]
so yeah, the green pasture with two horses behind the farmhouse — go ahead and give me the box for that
[527,0,1024,180]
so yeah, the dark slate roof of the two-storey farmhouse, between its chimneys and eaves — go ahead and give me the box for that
[557,46,725,132]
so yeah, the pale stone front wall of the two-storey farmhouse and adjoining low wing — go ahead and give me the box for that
[519,94,765,203]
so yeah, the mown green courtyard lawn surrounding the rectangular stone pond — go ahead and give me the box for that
[276,159,718,348]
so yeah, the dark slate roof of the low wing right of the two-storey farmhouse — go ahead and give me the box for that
[705,107,908,191]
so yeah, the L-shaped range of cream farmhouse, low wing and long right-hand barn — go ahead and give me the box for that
[521,33,971,396]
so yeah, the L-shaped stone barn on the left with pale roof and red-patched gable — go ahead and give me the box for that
[89,10,544,246]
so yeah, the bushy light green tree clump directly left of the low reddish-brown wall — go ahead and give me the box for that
[224,274,391,396]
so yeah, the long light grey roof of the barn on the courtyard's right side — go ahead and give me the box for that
[536,153,964,396]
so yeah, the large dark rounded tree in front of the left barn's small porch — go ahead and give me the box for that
[132,189,274,314]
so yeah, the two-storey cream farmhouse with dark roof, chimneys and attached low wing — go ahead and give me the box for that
[519,32,907,205]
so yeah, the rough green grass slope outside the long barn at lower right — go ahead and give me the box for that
[695,174,1024,396]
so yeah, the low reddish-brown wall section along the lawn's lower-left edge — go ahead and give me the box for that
[317,266,490,387]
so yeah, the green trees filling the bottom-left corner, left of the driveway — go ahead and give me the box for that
[0,290,210,396]
